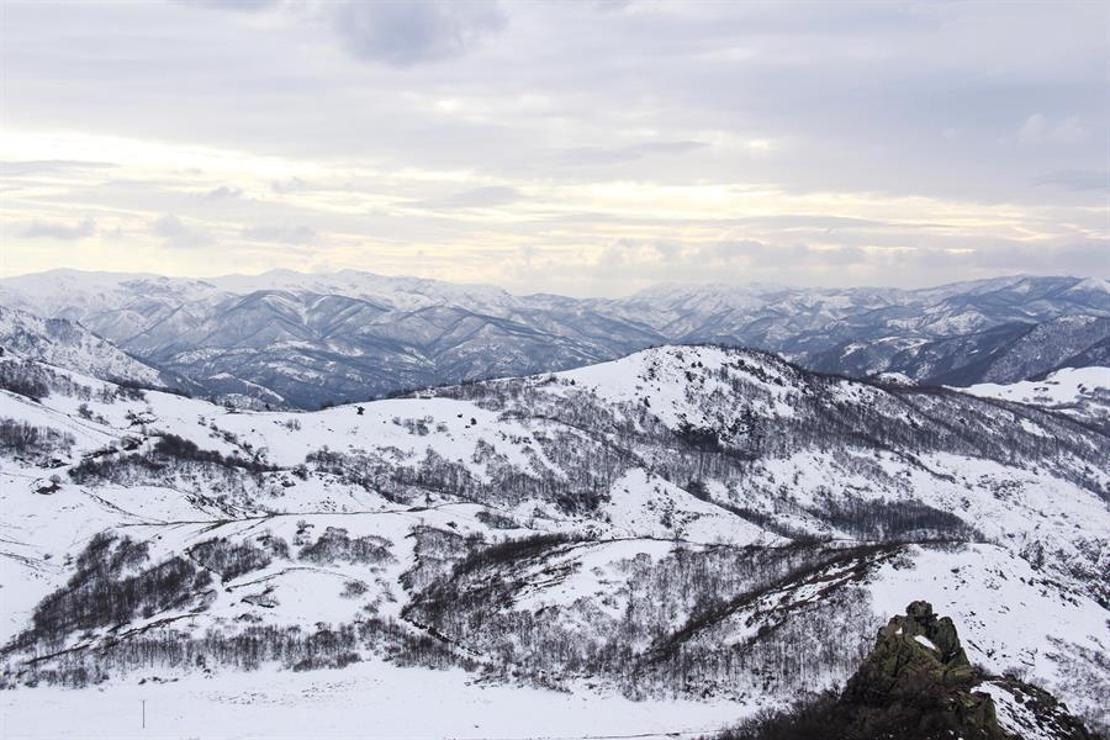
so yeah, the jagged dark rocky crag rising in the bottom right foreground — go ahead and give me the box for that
[840,601,1008,740]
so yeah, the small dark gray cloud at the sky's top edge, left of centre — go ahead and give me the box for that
[333,0,507,67]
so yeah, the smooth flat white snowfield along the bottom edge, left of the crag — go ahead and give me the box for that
[0,660,754,740]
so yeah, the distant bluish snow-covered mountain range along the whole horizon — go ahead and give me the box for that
[0,271,1110,408]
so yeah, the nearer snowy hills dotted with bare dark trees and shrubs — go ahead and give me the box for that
[0,346,1110,736]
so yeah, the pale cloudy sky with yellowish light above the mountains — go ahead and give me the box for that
[0,0,1110,295]
